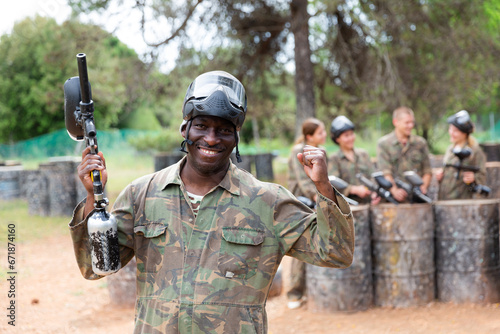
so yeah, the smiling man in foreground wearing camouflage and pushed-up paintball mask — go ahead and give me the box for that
[70,71,354,333]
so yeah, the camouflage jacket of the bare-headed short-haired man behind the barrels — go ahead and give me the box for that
[377,131,432,180]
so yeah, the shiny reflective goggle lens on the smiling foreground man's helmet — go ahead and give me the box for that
[185,71,247,112]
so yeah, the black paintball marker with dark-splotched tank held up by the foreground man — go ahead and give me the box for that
[64,53,121,275]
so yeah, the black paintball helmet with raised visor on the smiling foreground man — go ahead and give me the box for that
[182,71,247,131]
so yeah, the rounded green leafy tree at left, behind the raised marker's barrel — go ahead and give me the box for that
[0,16,169,142]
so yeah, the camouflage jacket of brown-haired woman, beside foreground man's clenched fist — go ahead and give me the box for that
[288,143,316,199]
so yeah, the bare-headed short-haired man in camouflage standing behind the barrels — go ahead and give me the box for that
[377,107,432,202]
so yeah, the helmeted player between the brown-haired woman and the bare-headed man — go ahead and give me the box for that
[328,116,380,204]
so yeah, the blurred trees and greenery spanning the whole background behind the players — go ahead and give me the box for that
[0,0,500,160]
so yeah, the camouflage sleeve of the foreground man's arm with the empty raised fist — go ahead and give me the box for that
[275,188,354,268]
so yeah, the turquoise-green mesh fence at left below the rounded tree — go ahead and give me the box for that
[0,129,156,161]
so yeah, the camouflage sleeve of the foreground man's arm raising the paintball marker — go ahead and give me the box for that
[69,188,134,280]
